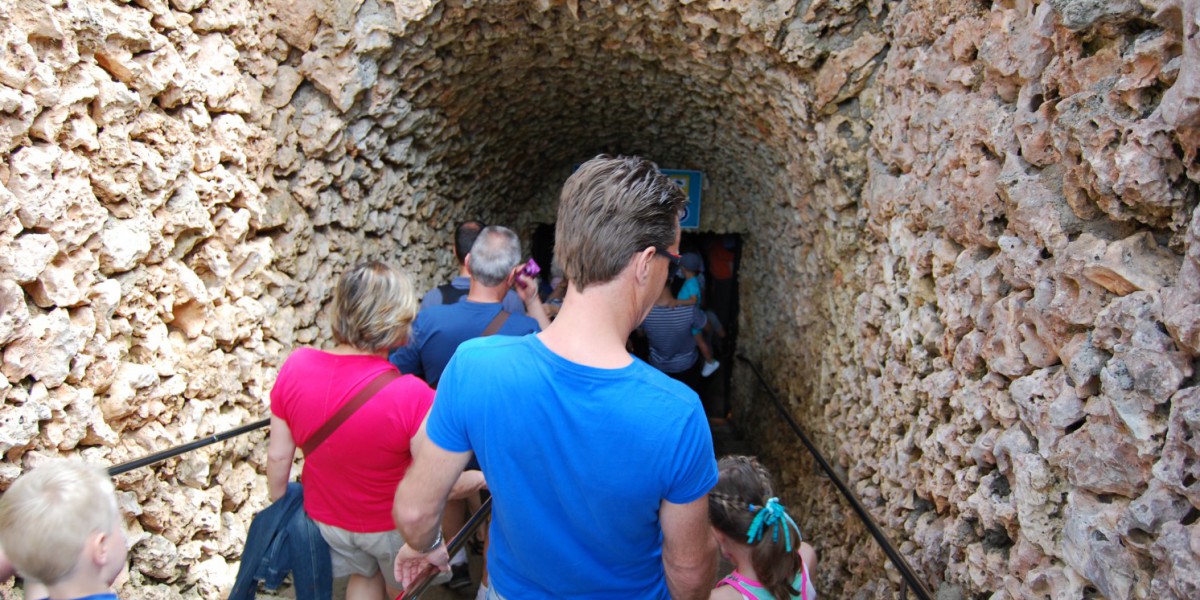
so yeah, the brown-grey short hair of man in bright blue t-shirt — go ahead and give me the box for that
[554,155,688,292]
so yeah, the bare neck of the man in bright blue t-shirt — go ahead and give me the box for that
[538,277,644,368]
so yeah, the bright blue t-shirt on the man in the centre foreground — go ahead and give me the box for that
[426,336,716,600]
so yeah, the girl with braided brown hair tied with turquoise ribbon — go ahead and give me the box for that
[708,456,817,600]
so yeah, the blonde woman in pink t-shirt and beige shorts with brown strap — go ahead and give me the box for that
[266,262,482,600]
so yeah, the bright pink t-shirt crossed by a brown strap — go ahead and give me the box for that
[271,348,433,533]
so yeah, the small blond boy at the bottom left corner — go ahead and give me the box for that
[0,460,127,600]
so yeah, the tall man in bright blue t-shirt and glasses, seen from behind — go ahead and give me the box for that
[394,156,716,600]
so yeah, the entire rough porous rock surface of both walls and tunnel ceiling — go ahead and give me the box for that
[0,0,1200,599]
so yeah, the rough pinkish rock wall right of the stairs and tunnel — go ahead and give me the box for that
[738,0,1200,599]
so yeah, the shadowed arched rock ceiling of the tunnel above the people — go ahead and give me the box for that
[338,5,804,229]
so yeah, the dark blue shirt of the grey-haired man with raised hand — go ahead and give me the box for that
[388,300,541,386]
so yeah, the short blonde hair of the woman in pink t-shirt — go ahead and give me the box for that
[332,260,416,353]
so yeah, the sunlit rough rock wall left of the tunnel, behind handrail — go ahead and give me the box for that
[0,0,450,598]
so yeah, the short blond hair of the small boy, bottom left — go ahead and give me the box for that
[0,460,120,586]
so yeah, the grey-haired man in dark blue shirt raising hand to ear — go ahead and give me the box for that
[388,226,550,388]
